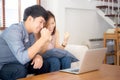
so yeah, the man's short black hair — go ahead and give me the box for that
[23,5,48,21]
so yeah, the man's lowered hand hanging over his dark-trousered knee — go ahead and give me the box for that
[31,54,43,69]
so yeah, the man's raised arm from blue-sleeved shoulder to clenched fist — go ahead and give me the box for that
[1,25,50,64]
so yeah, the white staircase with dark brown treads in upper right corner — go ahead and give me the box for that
[96,0,120,28]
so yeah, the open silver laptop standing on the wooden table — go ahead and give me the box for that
[60,48,107,74]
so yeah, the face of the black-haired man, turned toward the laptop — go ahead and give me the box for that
[32,16,45,33]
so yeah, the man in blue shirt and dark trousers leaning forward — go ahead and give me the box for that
[0,5,50,80]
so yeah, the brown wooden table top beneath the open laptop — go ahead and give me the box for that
[19,64,120,80]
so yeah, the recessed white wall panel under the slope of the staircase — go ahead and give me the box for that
[65,8,109,44]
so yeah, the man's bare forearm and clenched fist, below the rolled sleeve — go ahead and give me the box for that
[28,28,51,59]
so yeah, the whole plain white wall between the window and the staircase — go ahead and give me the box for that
[42,0,110,44]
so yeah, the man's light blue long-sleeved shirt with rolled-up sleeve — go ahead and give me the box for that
[0,22,34,69]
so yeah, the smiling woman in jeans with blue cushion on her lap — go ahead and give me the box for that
[38,11,78,72]
